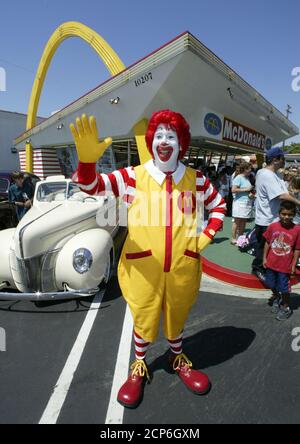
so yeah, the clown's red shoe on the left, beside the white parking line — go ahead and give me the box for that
[117,359,150,409]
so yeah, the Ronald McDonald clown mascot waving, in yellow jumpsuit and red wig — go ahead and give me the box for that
[70,110,226,408]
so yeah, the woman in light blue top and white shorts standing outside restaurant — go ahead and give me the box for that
[231,162,253,245]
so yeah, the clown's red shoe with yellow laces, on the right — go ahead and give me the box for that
[169,353,211,395]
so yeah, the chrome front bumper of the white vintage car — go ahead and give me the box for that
[0,287,99,301]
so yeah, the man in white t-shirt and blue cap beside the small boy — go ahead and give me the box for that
[252,147,300,282]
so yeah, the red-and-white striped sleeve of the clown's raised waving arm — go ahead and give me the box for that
[72,162,136,204]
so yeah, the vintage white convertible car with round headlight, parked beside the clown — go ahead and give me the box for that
[0,176,118,301]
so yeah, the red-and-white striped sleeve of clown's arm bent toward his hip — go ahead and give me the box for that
[196,171,226,239]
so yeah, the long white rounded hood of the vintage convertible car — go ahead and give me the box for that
[14,201,106,259]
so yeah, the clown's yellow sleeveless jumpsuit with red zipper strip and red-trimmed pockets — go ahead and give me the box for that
[118,165,201,342]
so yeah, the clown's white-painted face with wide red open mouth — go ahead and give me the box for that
[152,123,179,173]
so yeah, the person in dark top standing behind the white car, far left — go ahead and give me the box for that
[8,171,34,221]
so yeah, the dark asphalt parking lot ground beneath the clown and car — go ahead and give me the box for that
[0,277,300,424]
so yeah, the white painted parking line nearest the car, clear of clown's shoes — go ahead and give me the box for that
[39,290,105,424]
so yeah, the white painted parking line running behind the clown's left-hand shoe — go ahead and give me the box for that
[105,305,133,424]
